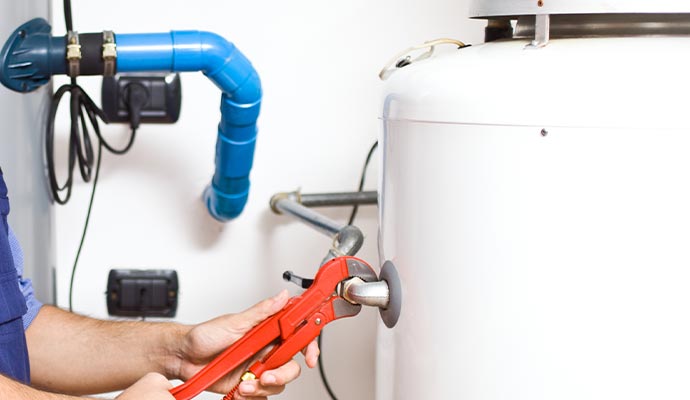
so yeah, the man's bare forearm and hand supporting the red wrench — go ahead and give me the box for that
[25,291,319,400]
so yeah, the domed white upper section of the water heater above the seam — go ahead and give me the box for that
[381,36,690,129]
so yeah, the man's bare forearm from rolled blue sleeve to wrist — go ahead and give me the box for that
[25,306,189,399]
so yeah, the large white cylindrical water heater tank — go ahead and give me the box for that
[377,0,690,400]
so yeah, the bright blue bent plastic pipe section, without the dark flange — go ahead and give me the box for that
[115,31,262,221]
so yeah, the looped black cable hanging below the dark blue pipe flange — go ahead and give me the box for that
[58,0,140,311]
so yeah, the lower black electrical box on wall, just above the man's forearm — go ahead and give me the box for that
[106,269,179,318]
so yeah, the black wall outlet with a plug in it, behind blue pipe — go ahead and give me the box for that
[101,73,182,124]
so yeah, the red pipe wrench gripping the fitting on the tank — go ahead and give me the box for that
[170,257,378,400]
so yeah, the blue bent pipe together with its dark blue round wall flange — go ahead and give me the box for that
[0,18,262,222]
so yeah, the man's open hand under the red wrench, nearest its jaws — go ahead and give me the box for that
[178,290,319,398]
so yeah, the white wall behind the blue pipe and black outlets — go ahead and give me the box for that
[53,0,483,400]
